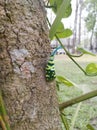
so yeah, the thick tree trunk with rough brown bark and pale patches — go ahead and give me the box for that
[0,0,61,130]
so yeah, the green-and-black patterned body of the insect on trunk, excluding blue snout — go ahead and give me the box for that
[45,55,56,81]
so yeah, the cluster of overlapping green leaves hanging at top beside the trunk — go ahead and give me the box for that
[49,0,72,39]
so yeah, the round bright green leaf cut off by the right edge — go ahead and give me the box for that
[86,63,97,75]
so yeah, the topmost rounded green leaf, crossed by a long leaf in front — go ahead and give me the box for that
[50,0,72,18]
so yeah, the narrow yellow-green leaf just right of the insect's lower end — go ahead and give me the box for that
[56,76,75,87]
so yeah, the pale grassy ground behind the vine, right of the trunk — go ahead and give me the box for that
[55,55,97,130]
